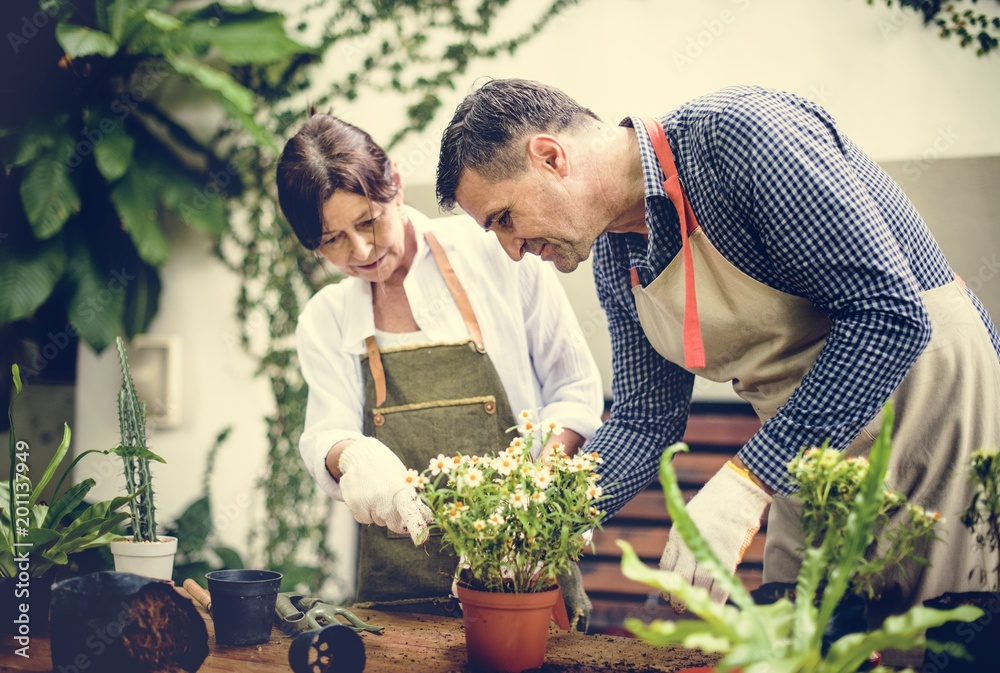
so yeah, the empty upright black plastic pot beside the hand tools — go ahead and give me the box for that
[205,570,282,645]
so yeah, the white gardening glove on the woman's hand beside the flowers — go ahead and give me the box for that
[339,437,433,545]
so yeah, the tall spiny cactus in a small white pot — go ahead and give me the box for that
[110,337,177,579]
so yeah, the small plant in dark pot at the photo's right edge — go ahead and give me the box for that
[924,447,1000,673]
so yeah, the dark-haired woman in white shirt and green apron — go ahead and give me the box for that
[277,115,603,616]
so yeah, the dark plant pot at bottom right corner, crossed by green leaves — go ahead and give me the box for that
[923,591,1000,673]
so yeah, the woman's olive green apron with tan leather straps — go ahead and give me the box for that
[357,233,517,614]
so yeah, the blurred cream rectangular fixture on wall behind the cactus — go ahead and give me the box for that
[128,334,181,429]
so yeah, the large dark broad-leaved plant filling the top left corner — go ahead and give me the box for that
[0,0,314,356]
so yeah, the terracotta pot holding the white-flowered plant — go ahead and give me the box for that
[458,585,559,673]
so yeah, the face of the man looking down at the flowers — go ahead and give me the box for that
[455,165,594,273]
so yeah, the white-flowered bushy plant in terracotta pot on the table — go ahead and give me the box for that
[408,411,604,671]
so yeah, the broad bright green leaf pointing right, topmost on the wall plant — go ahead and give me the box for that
[183,10,315,65]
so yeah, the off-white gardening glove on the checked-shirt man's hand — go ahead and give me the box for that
[660,463,771,610]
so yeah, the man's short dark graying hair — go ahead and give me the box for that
[437,79,598,210]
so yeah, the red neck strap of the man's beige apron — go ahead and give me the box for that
[633,119,705,369]
